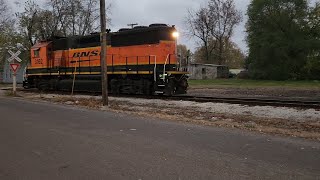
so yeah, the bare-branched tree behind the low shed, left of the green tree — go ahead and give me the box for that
[187,0,242,64]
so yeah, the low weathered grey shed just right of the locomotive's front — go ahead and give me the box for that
[188,63,229,79]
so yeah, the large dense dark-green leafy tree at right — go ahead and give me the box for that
[247,0,316,80]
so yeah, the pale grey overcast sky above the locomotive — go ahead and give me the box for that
[107,0,250,51]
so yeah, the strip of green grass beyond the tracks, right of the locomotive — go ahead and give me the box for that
[189,79,320,89]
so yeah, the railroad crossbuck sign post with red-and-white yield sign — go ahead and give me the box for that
[8,50,22,96]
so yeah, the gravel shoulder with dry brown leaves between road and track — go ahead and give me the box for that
[0,89,320,141]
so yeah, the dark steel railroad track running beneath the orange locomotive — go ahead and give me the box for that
[3,89,320,109]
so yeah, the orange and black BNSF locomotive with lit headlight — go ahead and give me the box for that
[23,24,188,95]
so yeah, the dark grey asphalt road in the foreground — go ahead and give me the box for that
[0,97,320,180]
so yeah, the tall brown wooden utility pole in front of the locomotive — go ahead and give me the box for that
[100,0,109,106]
